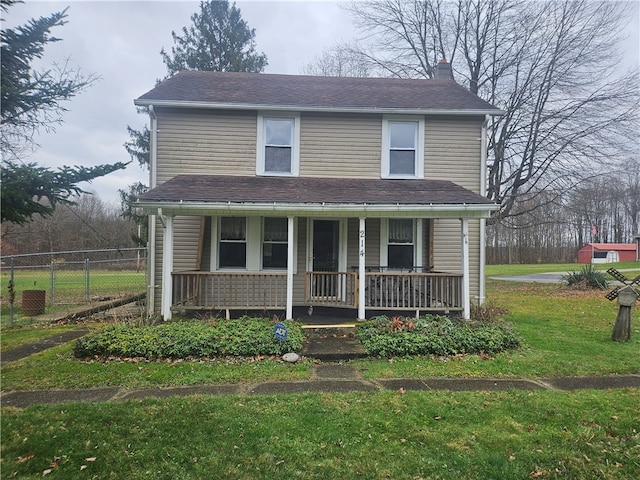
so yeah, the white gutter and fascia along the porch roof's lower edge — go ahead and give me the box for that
[136,201,499,218]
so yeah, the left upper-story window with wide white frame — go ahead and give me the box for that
[256,114,300,176]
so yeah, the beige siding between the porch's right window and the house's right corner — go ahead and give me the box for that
[433,218,480,303]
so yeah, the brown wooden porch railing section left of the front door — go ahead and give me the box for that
[172,272,287,310]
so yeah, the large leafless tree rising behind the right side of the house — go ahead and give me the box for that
[340,0,640,221]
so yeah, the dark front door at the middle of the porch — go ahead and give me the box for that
[310,220,340,300]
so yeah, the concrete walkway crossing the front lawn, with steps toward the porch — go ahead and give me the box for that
[0,327,640,408]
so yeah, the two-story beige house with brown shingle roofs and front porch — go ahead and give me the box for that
[135,63,500,319]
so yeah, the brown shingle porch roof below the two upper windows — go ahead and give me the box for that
[140,175,493,206]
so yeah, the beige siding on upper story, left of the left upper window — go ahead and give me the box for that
[156,109,257,184]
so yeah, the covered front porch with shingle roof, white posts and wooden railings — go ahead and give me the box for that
[139,175,496,320]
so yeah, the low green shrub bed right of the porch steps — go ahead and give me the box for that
[358,315,521,357]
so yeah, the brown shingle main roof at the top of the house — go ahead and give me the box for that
[136,70,500,114]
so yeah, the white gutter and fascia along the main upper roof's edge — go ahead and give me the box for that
[133,99,505,116]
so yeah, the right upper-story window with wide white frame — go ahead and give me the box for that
[382,117,424,178]
